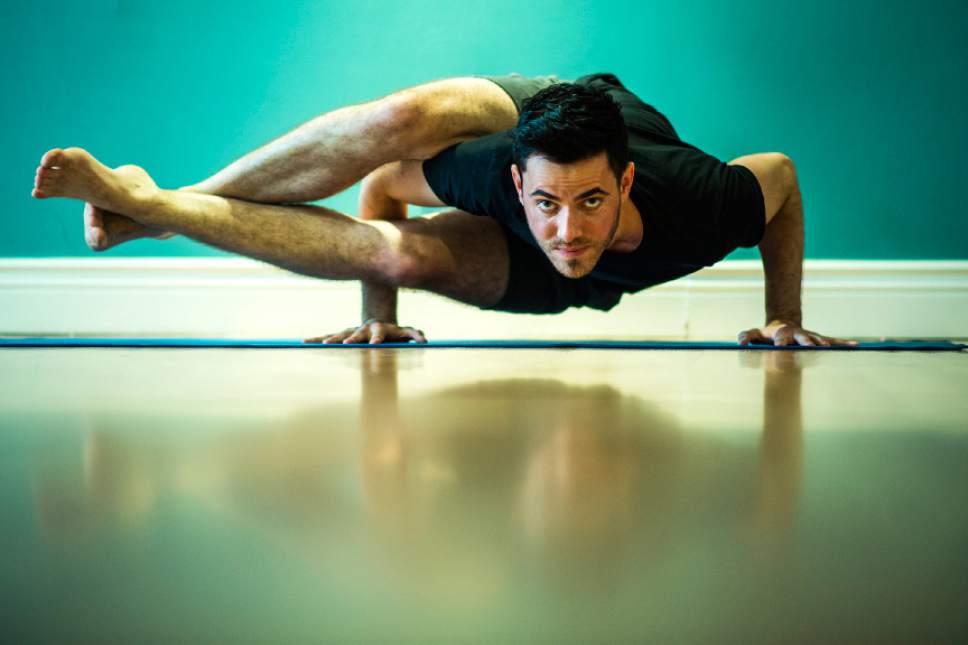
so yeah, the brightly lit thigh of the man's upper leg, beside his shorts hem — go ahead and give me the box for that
[387,76,518,159]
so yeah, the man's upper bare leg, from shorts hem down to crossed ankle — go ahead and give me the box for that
[189,77,518,203]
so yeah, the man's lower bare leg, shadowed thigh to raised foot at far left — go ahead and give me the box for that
[34,148,509,306]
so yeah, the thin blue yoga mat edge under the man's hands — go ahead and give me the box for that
[0,338,968,352]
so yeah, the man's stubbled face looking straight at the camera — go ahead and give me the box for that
[511,152,632,278]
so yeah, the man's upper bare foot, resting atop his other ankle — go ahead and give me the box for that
[33,148,158,213]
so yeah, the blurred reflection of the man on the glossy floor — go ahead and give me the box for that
[26,350,804,642]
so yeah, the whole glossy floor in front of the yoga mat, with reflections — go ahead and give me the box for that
[0,349,968,643]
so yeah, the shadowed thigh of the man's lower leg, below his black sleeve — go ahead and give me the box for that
[394,210,510,308]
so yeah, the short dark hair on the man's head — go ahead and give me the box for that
[511,83,629,182]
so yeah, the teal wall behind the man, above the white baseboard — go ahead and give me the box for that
[0,0,968,259]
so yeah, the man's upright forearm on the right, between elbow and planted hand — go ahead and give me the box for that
[759,181,804,327]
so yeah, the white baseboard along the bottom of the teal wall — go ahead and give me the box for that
[0,258,968,340]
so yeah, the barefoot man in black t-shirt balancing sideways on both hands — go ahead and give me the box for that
[33,74,849,345]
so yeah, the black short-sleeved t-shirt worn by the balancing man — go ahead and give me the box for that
[423,74,765,292]
